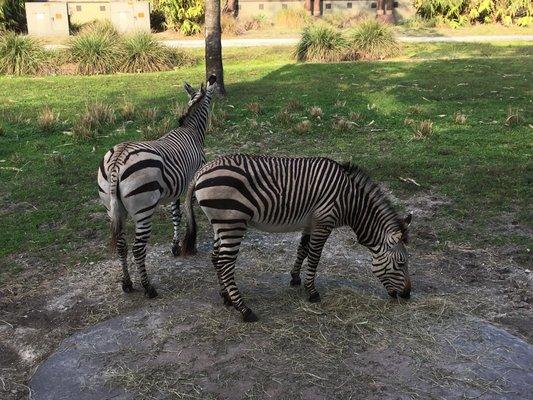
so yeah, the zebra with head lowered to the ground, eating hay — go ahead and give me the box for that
[182,155,411,321]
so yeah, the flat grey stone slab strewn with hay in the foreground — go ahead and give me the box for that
[29,301,533,400]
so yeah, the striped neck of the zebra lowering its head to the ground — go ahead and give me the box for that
[346,171,403,252]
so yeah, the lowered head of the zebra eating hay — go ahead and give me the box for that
[372,214,412,299]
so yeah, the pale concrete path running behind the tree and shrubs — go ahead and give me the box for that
[45,35,533,49]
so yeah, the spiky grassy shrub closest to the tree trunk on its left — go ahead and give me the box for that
[119,32,179,72]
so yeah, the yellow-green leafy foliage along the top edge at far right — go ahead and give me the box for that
[415,0,533,27]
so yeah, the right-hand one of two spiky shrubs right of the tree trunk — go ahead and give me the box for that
[348,19,400,60]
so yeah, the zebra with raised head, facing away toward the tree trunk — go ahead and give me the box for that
[98,75,216,298]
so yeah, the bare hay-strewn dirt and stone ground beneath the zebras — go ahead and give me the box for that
[0,193,533,400]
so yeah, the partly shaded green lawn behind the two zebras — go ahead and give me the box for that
[0,45,533,282]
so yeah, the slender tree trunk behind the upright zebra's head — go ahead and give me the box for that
[205,0,226,94]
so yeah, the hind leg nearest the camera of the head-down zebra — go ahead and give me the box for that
[217,232,258,322]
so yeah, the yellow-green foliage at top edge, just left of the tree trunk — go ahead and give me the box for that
[153,0,205,35]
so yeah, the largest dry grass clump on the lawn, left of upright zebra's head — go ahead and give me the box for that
[73,101,116,139]
